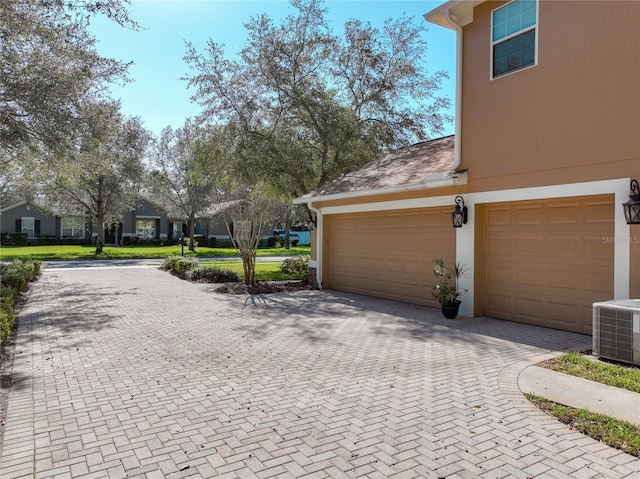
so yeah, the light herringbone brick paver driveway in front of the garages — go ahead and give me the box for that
[0,267,640,479]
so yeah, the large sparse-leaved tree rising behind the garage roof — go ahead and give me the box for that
[185,0,450,197]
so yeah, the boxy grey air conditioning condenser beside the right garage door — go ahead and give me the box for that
[593,299,640,366]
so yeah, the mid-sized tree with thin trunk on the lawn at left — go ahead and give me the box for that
[31,102,149,253]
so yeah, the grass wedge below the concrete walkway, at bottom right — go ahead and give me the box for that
[526,394,640,457]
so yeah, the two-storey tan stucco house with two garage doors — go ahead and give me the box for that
[296,0,640,334]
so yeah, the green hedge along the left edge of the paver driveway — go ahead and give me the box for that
[0,260,41,345]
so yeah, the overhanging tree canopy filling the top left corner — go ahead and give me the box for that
[0,0,137,150]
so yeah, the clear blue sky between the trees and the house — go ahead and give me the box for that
[91,0,455,139]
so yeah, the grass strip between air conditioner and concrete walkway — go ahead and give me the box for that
[541,352,640,393]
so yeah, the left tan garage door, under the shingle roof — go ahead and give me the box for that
[323,207,455,306]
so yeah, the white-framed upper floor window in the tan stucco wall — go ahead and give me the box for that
[491,0,538,78]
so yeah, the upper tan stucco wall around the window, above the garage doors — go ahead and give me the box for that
[461,1,640,191]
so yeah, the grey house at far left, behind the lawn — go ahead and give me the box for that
[0,201,89,243]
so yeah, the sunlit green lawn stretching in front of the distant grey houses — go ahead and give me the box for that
[0,245,309,260]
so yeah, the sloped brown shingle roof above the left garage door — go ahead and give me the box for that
[295,135,466,203]
